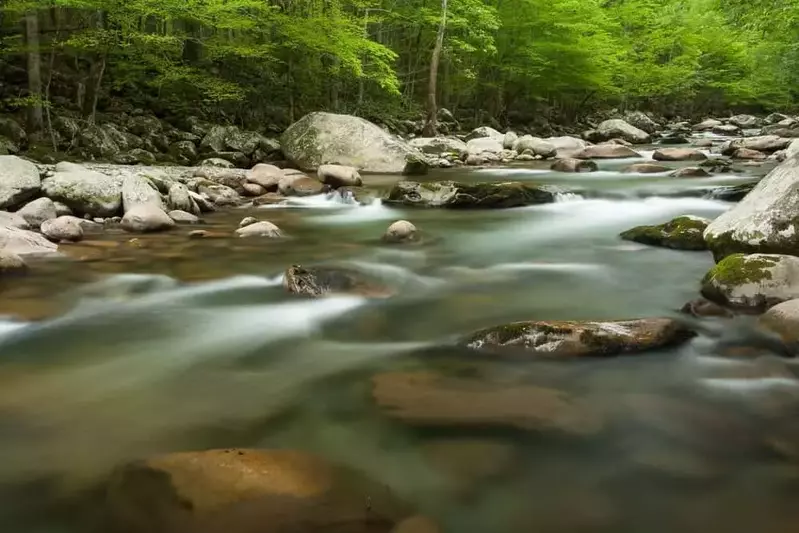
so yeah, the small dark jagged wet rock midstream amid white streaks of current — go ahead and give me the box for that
[284,262,394,298]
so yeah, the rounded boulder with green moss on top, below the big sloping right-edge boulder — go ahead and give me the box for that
[702,254,799,311]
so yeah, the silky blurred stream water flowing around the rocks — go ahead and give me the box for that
[0,149,799,533]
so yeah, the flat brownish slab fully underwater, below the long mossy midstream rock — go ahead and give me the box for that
[372,372,605,437]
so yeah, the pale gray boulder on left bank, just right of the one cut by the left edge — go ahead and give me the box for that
[42,162,122,217]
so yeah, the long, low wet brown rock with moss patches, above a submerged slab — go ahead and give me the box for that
[463,318,694,358]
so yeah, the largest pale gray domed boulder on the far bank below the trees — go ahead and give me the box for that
[280,112,424,174]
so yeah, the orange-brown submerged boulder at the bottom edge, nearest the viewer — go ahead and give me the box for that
[104,449,413,533]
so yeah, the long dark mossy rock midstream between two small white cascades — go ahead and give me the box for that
[384,181,555,209]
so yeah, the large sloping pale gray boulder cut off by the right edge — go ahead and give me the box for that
[704,155,799,260]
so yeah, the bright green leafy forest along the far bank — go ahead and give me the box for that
[0,0,799,131]
